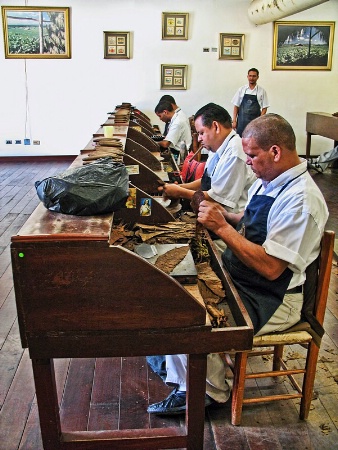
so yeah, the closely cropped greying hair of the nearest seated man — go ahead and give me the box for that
[242,113,296,150]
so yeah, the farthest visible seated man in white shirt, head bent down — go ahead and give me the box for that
[155,100,192,160]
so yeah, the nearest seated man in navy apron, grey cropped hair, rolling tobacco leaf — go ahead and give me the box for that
[148,114,328,415]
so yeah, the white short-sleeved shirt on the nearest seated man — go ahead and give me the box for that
[248,160,329,289]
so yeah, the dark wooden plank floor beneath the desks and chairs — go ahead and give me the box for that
[0,160,338,450]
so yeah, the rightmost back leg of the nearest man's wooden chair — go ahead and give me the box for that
[299,341,319,420]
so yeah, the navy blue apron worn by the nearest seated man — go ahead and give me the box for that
[222,174,302,333]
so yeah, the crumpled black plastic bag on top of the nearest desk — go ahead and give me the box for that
[35,157,129,216]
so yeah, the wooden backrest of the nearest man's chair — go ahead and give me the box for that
[302,230,335,342]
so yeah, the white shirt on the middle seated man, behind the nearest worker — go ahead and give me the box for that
[205,130,256,212]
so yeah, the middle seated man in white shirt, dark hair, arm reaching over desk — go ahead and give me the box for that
[159,103,255,212]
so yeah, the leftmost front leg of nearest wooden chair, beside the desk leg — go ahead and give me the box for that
[231,352,248,425]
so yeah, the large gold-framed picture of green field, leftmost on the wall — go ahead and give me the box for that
[1,6,71,59]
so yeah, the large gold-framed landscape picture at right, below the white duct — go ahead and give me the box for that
[272,22,335,70]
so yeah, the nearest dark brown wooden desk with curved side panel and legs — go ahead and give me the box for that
[11,104,253,450]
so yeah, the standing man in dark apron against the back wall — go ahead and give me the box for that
[231,67,270,136]
